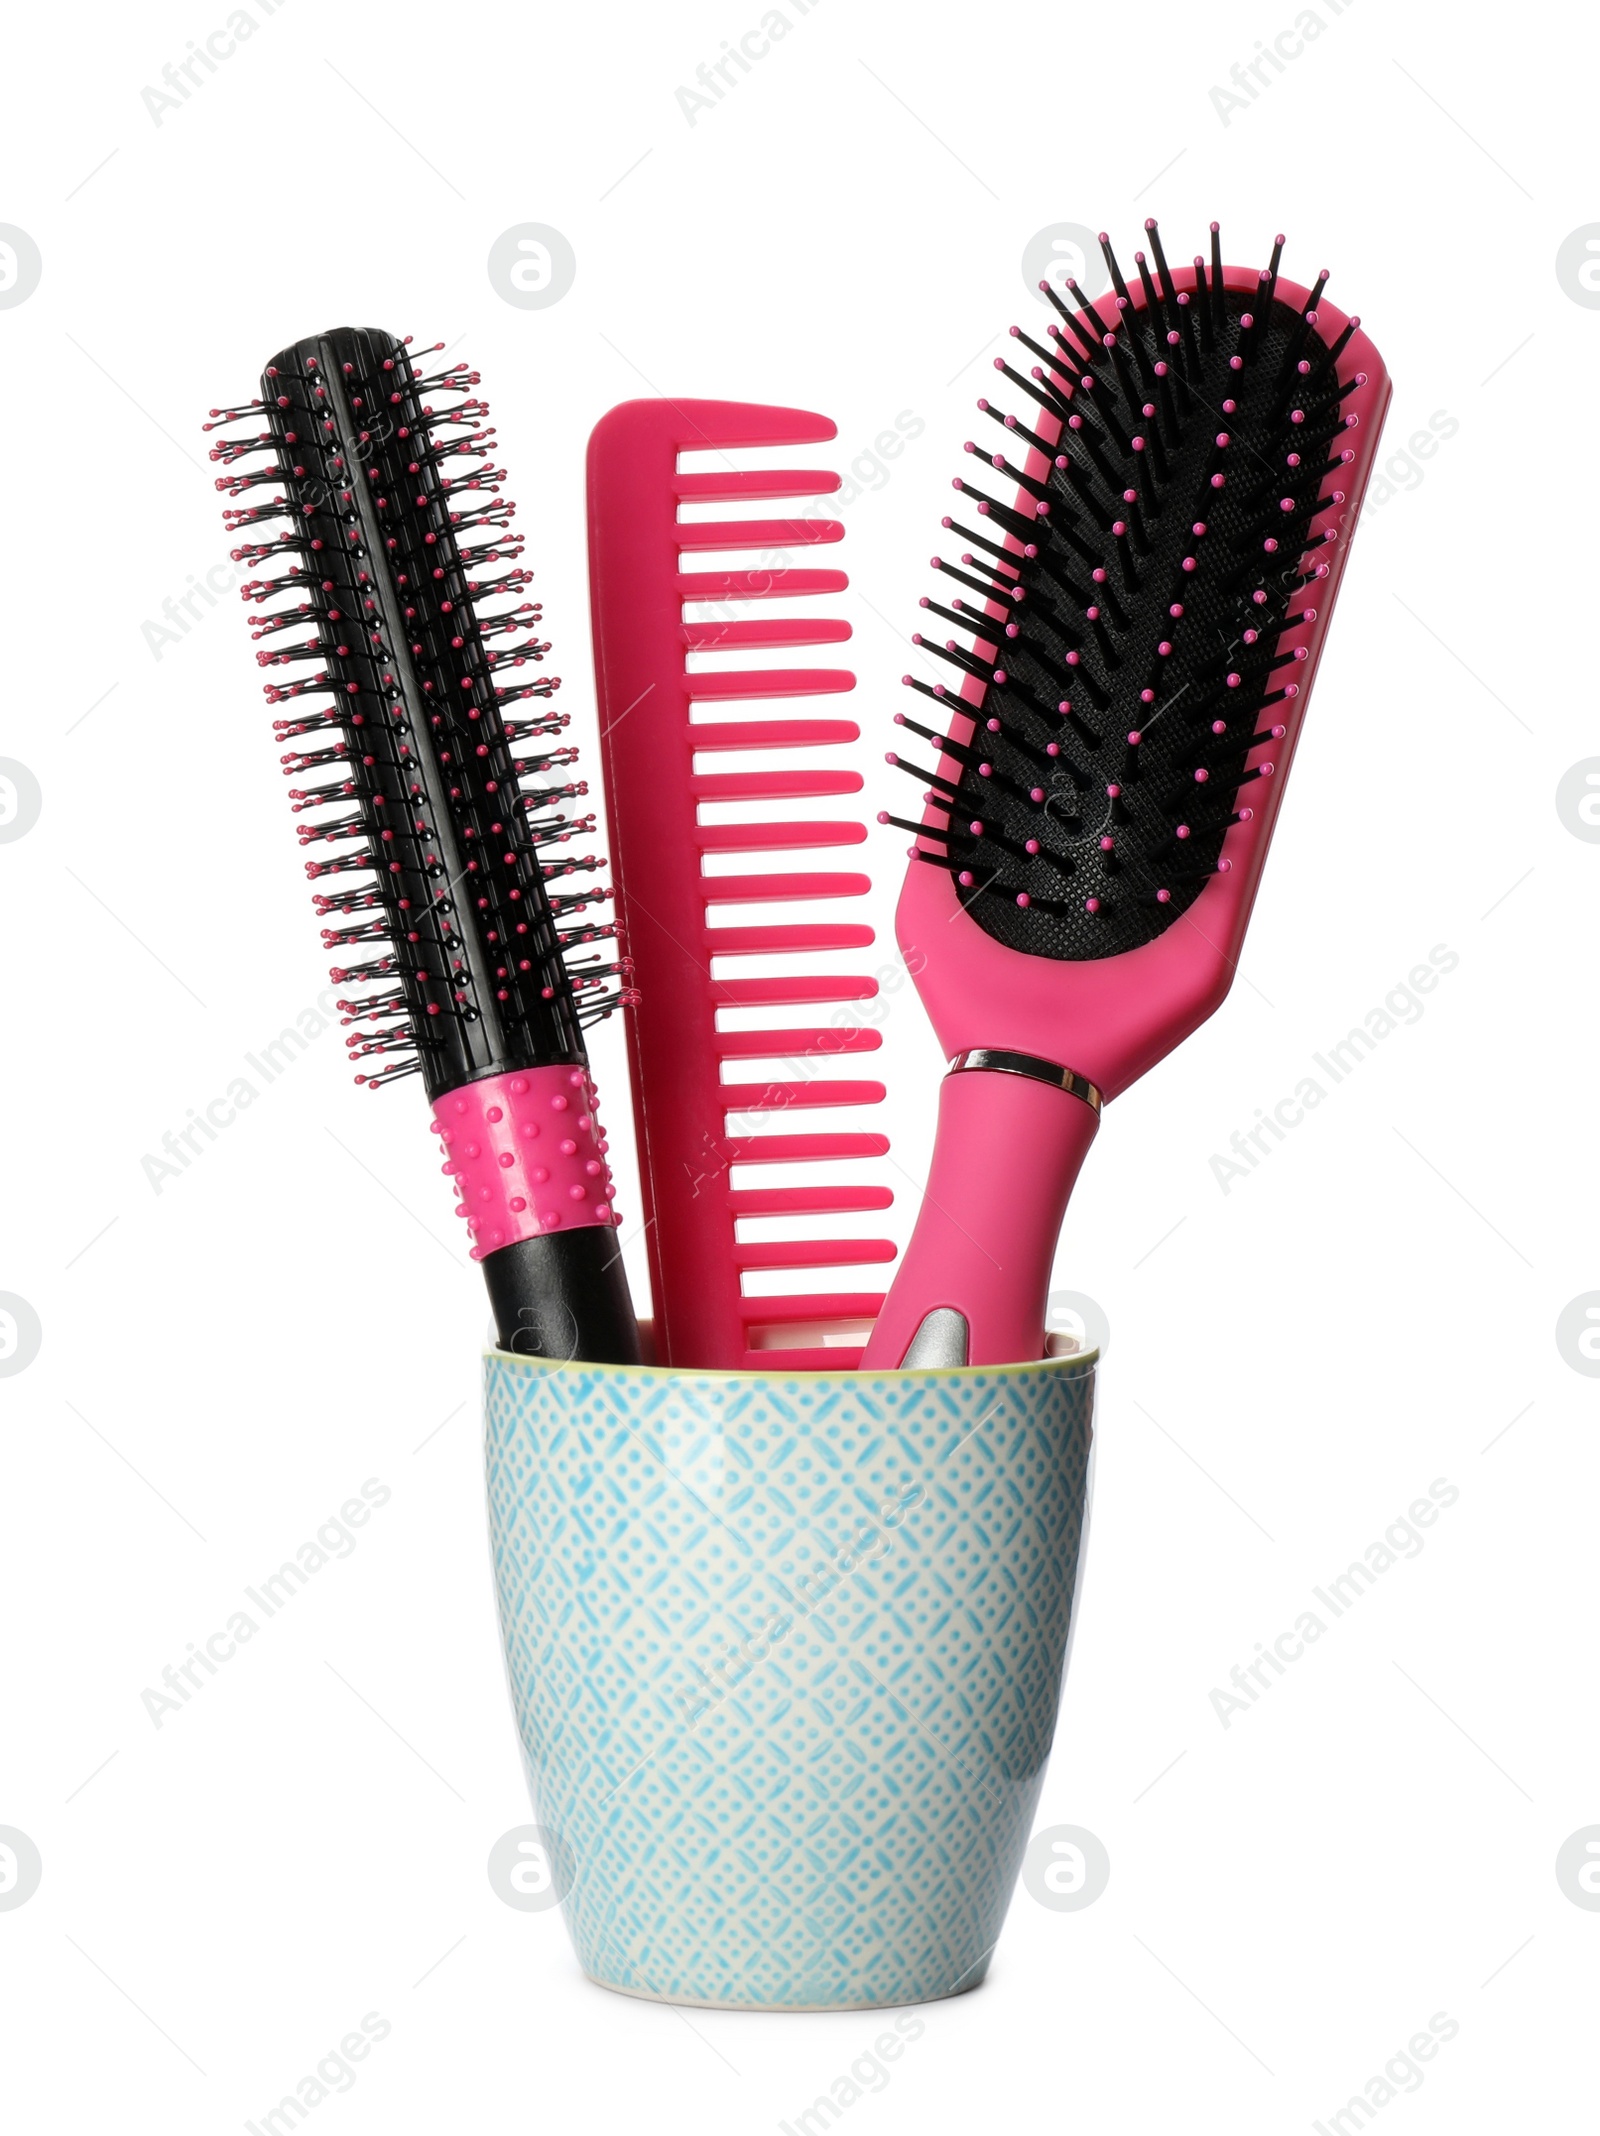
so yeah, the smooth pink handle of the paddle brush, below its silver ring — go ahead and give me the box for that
[861,1068,1100,1371]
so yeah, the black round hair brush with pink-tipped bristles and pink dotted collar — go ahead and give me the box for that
[207,327,639,1363]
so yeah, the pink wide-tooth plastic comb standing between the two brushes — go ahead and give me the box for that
[590,402,895,1371]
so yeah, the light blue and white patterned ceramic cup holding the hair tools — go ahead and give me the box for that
[485,1350,1094,2010]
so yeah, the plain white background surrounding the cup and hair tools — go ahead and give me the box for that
[0,0,1600,2136]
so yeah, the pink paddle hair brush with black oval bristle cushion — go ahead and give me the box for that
[863,222,1391,1367]
